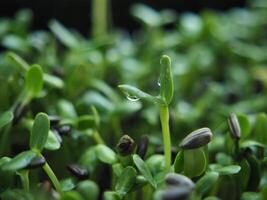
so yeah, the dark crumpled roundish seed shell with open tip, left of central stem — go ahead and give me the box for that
[116,135,135,156]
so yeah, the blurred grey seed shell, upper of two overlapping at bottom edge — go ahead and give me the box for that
[165,173,195,189]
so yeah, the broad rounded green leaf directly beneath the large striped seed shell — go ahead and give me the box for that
[184,148,207,178]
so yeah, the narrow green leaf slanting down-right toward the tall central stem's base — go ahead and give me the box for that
[133,154,157,188]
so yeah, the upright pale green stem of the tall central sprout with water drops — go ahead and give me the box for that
[160,106,171,171]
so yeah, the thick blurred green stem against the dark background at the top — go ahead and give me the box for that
[92,0,108,37]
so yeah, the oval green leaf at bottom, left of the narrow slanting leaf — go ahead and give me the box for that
[115,166,137,196]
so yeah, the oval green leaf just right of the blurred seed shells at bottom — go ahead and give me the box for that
[195,172,219,196]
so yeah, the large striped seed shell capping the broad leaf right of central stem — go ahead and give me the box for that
[180,128,212,149]
